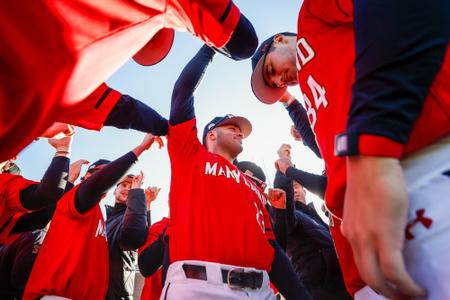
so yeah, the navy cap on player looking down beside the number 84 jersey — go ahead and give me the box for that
[251,32,296,104]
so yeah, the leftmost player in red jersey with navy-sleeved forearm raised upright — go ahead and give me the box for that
[0,137,72,244]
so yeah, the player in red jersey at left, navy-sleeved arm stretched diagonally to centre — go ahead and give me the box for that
[23,134,160,299]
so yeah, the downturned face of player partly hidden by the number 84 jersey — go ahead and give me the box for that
[263,42,298,87]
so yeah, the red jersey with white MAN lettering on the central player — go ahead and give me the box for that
[168,119,274,271]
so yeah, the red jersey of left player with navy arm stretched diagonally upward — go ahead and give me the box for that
[23,185,109,300]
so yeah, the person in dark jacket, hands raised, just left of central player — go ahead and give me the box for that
[106,171,159,300]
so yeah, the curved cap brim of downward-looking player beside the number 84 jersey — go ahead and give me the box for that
[251,56,287,104]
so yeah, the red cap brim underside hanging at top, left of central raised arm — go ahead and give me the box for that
[133,28,175,66]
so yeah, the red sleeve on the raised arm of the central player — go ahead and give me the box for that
[167,118,204,162]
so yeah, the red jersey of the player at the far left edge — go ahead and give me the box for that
[0,174,39,245]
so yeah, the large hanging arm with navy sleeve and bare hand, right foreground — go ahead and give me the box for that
[337,0,450,298]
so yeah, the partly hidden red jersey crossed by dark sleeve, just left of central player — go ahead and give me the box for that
[138,218,169,300]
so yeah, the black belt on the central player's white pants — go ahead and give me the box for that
[183,264,264,290]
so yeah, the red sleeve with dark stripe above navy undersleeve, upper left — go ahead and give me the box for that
[58,83,122,130]
